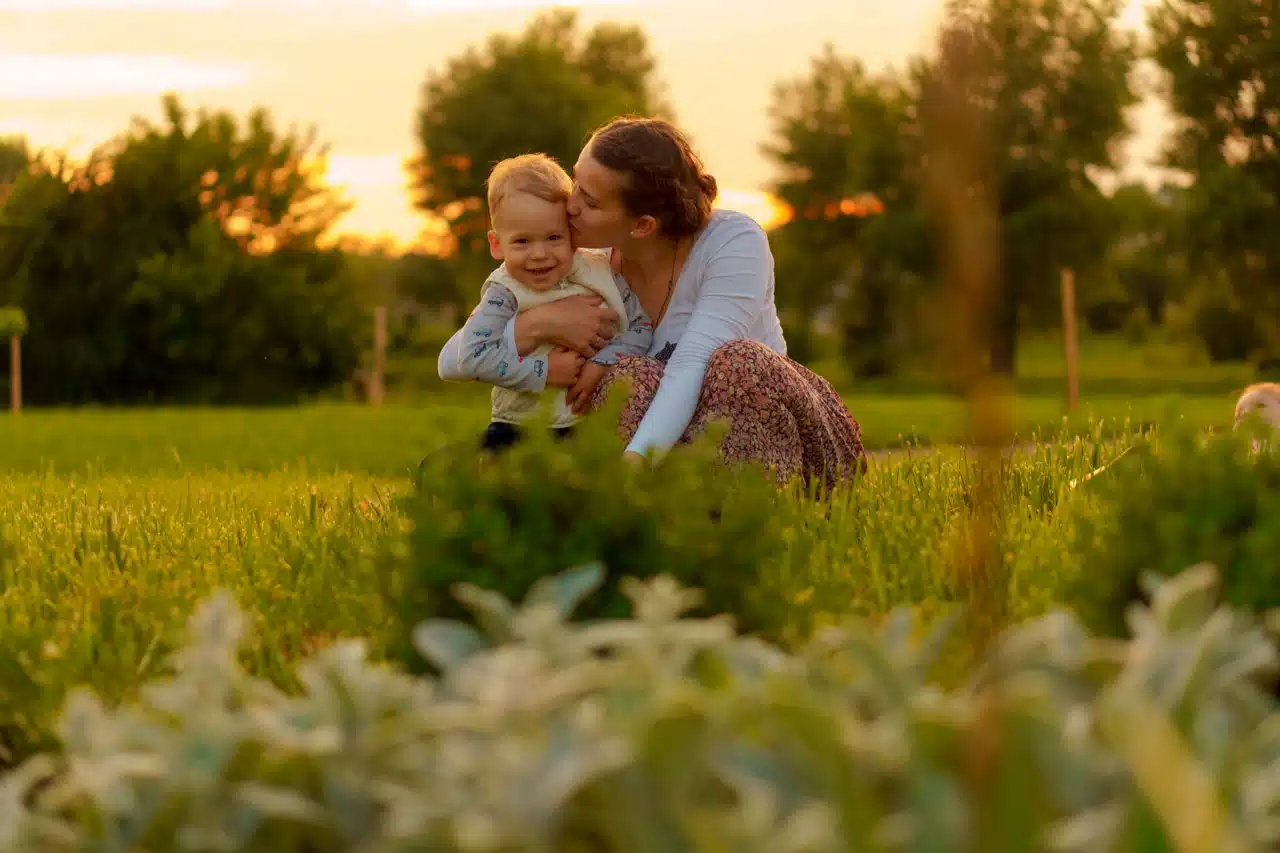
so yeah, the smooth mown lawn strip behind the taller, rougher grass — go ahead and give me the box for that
[0,393,1213,482]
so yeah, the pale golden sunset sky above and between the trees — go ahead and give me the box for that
[0,0,1164,242]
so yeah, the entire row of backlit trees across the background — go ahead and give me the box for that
[0,0,1280,405]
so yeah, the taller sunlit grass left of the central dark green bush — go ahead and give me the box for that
[0,471,407,767]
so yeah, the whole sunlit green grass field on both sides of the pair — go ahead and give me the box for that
[0,327,1252,752]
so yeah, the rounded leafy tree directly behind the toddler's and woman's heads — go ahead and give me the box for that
[408,9,669,308]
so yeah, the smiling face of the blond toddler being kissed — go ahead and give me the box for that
[489,192,573,291]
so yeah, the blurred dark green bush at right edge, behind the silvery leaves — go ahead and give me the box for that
[1068,427,1280,635]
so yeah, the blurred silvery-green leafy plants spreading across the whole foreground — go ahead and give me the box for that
[0,560,1280,853]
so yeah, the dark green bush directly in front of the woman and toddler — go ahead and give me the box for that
[389,389,799,660]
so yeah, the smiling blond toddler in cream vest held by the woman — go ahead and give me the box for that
[448,154,653,451]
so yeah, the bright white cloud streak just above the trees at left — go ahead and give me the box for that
[0,53,253,101]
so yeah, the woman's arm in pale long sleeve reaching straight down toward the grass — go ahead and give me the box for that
[627,222,773,455]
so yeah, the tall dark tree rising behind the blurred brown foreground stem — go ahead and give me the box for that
[915,0,1137,375]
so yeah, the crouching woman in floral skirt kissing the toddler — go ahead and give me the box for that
[440,118,867,491]
